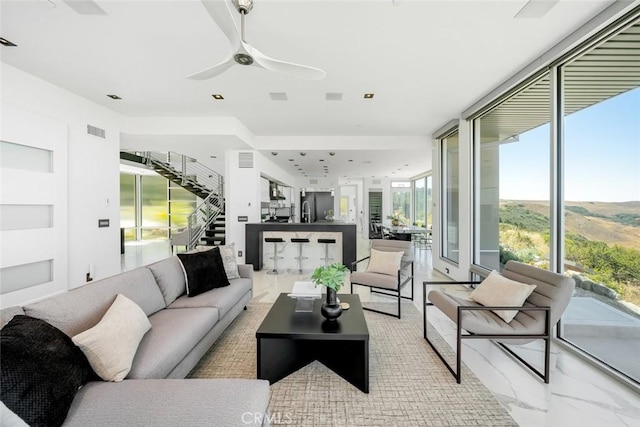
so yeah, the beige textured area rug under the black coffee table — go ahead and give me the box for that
[189,303,517,426]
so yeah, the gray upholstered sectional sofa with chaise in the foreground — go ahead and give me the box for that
[0,256,269,426]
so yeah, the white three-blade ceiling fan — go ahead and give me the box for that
[187,0,327,80]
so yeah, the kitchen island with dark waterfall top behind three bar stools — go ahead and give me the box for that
[245,221,356,270]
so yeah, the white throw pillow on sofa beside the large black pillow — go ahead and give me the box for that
[72,294,151,382]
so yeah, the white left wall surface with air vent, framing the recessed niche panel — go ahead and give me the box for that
[1,63,123,304]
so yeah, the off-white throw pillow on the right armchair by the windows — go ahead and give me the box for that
[470,270,536,323]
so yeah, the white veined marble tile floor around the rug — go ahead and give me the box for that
[123,240,640,427]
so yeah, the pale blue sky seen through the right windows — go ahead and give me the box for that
[500,88,640,202]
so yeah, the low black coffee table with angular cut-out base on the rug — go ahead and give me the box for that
[256,294,369,393]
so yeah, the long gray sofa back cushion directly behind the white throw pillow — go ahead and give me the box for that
[24,267,166,337]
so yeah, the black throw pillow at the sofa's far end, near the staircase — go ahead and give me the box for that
[178,247,229,297]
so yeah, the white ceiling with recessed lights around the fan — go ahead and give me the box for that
[0,0,613,176]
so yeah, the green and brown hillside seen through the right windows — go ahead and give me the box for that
[500,200,640,307]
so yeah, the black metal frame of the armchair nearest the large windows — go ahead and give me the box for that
[422,281,551,384]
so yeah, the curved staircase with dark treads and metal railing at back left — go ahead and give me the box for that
[120,151,226,249]
